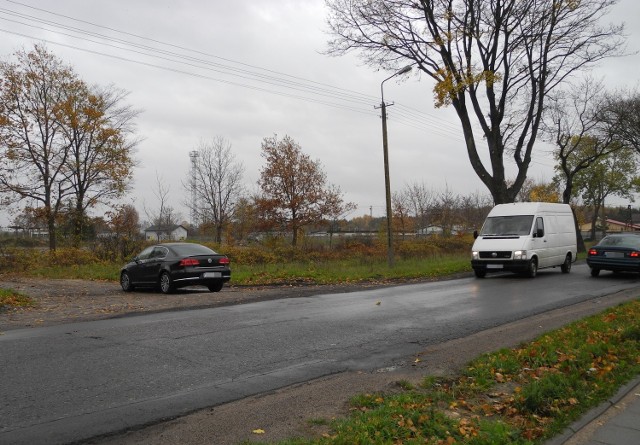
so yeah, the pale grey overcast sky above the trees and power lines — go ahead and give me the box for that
[0,0,640,225]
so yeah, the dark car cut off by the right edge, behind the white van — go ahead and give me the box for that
[587,232,640,277]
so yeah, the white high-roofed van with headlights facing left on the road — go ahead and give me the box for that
[471,202,578,278]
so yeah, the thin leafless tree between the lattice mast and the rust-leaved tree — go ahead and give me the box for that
[186,136,244,243]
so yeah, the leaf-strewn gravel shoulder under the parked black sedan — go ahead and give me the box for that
[0,275,390,332]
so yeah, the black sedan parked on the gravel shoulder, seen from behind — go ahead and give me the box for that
[120,243,231,294]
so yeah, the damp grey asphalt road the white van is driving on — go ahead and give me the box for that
[0,265,640,444]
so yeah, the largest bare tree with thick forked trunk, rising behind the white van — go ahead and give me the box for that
[326,0,624,203]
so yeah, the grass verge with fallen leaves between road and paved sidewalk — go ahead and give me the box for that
[252,300,640,445]
